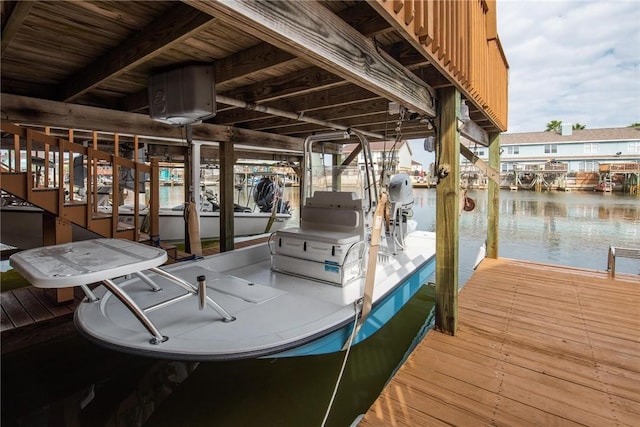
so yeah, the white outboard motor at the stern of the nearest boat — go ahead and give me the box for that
[387,173,413,253]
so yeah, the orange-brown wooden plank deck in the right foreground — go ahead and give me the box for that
[359,258,640,427]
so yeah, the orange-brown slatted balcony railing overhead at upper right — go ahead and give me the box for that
[371,0,509,131]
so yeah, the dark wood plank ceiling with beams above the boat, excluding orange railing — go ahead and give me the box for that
[0,0,498,160]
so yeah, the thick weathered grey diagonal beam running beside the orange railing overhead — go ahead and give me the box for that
[189,0,435,117]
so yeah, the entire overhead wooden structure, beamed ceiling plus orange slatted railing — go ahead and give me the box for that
[1,0,508,157]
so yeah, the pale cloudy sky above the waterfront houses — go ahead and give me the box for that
[497,0,640,132]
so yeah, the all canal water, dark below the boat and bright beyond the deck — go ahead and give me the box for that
[1,189,640,427]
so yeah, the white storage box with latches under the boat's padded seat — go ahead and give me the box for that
[269,228,365,286]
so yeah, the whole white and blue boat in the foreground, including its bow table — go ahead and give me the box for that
[10,131,436,360]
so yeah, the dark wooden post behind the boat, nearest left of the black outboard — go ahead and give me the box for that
[220,141,235,252]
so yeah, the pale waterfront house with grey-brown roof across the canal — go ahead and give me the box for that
[462,124,640,191]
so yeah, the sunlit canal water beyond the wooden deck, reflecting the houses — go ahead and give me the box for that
[413,189,640,282]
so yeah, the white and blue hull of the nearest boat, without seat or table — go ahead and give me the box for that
[75,232,435,360]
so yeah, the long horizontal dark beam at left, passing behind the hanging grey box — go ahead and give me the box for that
[0,93,304,152]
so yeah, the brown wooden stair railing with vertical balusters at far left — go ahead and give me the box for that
[0,121,159,241]
